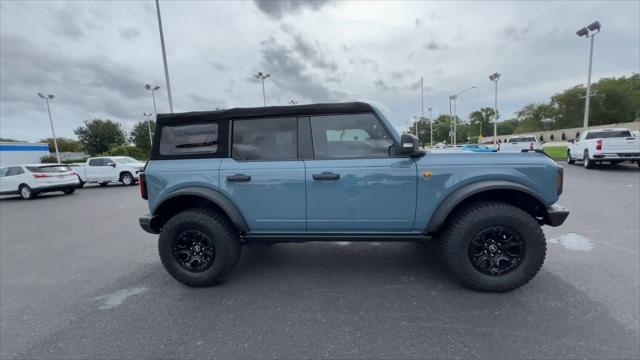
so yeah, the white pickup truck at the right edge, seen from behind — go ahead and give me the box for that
[567,128,640,169]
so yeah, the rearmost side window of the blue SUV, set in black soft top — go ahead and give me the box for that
[159,122,218,156]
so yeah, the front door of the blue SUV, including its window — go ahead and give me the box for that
[305,113,417,233]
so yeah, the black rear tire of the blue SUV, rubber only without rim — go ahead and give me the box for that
[158,208,240,287]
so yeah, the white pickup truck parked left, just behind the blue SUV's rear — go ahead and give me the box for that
[71,156,145,187]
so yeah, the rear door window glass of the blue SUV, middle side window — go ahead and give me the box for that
[231,118,298,160]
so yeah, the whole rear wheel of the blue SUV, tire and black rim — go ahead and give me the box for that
[158,208,240,286]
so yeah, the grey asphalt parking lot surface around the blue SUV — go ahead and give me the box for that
[0,163,640,359]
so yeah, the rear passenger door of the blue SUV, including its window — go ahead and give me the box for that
[220,117,306,232]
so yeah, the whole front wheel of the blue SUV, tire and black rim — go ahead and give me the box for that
[440,201,547,292]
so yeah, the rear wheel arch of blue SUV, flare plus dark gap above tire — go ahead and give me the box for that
[151,187,249,232]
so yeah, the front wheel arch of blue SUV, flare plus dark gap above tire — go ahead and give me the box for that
[426,180,547,233]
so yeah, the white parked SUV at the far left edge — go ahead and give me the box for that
[0,164,80,200]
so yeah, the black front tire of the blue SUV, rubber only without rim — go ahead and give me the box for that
[439,201,547,292]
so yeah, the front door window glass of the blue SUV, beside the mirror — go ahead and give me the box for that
[311,114,393,159]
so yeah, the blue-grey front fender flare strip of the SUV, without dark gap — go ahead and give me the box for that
[427,180,546,233]
